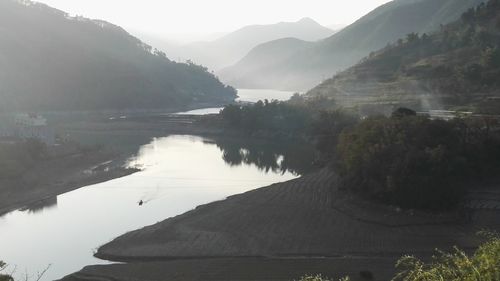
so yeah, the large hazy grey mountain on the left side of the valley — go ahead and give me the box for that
[0,0,236,111]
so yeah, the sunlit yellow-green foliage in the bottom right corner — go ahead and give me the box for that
[393,232,500,281]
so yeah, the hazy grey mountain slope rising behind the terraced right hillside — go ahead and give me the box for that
[220,0,483,90]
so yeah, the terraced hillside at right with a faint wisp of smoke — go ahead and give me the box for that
[307,0,500,114]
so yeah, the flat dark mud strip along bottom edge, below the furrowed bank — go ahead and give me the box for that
[63,257,394,281]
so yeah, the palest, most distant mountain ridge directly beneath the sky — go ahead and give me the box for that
[165,18,334,70]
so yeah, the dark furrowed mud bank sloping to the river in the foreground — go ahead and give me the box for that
[62,169,500,280]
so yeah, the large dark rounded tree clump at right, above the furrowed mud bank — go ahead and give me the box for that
[337,112,500,209]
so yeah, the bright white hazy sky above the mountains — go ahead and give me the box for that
[38,0,390,41]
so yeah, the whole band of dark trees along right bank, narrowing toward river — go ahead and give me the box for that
[221,99,500,210]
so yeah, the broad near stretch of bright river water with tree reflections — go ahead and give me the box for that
[0,88,313,280]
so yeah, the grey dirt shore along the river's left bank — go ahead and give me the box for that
[0,150,137,216]
